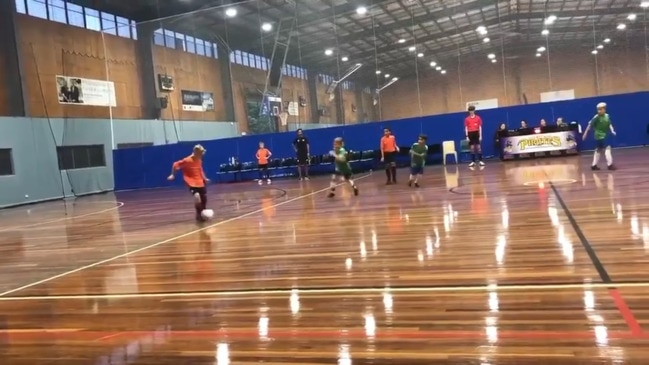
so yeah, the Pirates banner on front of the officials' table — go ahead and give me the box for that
[500,131,577,155]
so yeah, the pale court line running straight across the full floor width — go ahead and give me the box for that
[0,282,649,302]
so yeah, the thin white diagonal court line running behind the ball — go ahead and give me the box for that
[0,172,372,297]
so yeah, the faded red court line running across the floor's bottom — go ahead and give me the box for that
[0,328,649,342]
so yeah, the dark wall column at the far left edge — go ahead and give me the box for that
[0,1,27,117]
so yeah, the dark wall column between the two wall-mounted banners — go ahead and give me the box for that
[135,23,160,119]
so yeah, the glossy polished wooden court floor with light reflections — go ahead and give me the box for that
[0,149,649,365]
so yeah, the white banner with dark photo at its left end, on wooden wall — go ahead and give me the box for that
[56,75,117,107]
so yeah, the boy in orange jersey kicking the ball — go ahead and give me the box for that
[167,144,210,221]
